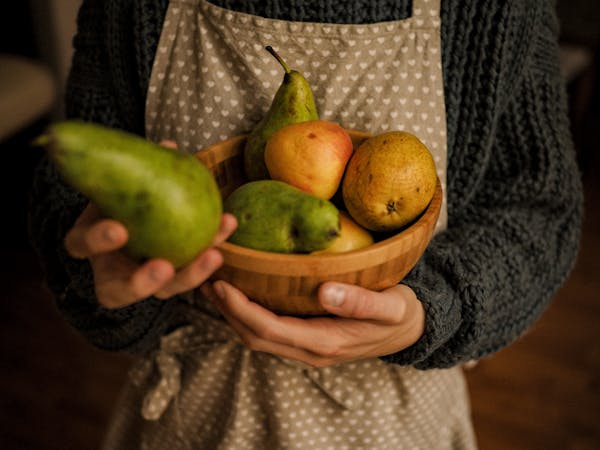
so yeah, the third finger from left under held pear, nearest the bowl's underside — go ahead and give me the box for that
[154,248,223,299]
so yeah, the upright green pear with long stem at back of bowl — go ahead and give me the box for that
[244,46,319,181]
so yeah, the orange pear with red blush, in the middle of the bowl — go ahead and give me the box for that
[265,120,353,200]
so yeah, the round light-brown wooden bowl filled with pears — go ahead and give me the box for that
[197,131,442,315]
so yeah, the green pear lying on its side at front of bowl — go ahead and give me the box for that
[223,180,340,253]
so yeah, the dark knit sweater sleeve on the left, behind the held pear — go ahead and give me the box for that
[30,0,176,352]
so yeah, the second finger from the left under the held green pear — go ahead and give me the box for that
[96,259,175,308]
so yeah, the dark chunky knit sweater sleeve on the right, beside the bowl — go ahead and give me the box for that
[383,2,583,369]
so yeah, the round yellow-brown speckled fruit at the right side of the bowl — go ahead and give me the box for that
[342,131,437,231]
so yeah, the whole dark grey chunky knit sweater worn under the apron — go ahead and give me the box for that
[31,0,583,369]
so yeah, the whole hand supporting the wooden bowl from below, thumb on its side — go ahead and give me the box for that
[202,281,425,367]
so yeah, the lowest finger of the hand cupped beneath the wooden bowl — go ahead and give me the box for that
[202,283,336,367]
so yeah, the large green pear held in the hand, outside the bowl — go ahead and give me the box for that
[41,121,222,268]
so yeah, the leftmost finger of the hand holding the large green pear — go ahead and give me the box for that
[64,219,128,259]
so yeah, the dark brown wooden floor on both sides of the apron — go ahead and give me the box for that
[0,138,600,450]
